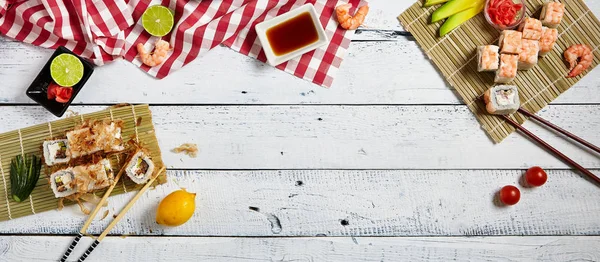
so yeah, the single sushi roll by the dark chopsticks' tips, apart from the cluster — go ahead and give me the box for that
[483,85,521,115]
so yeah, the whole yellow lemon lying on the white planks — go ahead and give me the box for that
[156,189,196,226]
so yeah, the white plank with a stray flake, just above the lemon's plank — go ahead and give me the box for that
[0,105,600,169]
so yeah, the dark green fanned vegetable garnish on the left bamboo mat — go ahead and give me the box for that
[10,155,42,202]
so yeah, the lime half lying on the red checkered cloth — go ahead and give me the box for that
[142,5,175,36]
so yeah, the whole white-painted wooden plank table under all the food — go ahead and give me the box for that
[0,1,600,261]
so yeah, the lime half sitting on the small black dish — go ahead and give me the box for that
[50,54,83,87]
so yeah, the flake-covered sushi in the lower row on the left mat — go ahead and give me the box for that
[73,159,114,193]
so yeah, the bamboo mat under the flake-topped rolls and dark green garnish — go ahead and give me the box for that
[0,105,166,221]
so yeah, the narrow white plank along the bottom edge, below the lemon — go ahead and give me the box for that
[0,236,600,262]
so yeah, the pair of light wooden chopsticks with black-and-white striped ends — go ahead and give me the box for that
[60,165,165,262]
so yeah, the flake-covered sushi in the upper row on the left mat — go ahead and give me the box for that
[67,121,125,158]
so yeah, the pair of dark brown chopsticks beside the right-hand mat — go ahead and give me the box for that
[503,108,600,186]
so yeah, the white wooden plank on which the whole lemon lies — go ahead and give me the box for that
[0,170,600,236]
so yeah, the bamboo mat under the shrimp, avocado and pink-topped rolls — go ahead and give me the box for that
[398,0,600,143]
